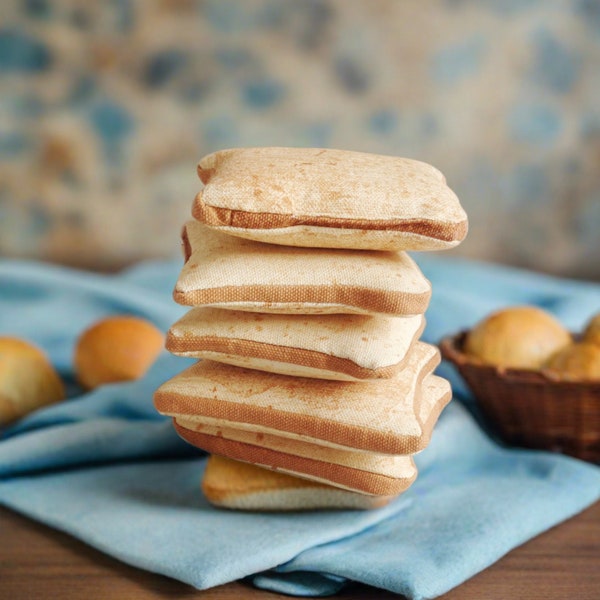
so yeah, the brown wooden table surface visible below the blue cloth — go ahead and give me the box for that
[0,503,600,600]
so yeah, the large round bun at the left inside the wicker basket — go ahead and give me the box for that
[464,306,572,369]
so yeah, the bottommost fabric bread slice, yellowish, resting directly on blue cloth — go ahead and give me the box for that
[202,455,393,511]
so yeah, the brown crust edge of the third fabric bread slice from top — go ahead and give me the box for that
[165,319,425,379]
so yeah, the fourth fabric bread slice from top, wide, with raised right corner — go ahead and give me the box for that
[154,342,440,454]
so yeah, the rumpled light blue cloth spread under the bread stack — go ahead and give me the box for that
[0,255,600,599]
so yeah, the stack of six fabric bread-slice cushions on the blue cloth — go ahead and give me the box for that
[155,148,467,510]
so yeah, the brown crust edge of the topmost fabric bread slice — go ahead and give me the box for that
[192,197,468,242]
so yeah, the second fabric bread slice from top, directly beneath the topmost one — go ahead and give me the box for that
[173,221,431,316]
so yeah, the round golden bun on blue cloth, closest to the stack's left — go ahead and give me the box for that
[74,316,164,389]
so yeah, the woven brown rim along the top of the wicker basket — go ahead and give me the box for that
[439,329,600,392]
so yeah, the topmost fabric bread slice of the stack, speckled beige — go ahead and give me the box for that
[192,147,468,250]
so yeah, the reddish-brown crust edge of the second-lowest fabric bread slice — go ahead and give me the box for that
[173,420,417,496]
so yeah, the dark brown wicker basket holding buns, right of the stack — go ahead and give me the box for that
[440,331,600,462]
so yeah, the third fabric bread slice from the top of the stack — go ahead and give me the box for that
[166,307,425,381]
